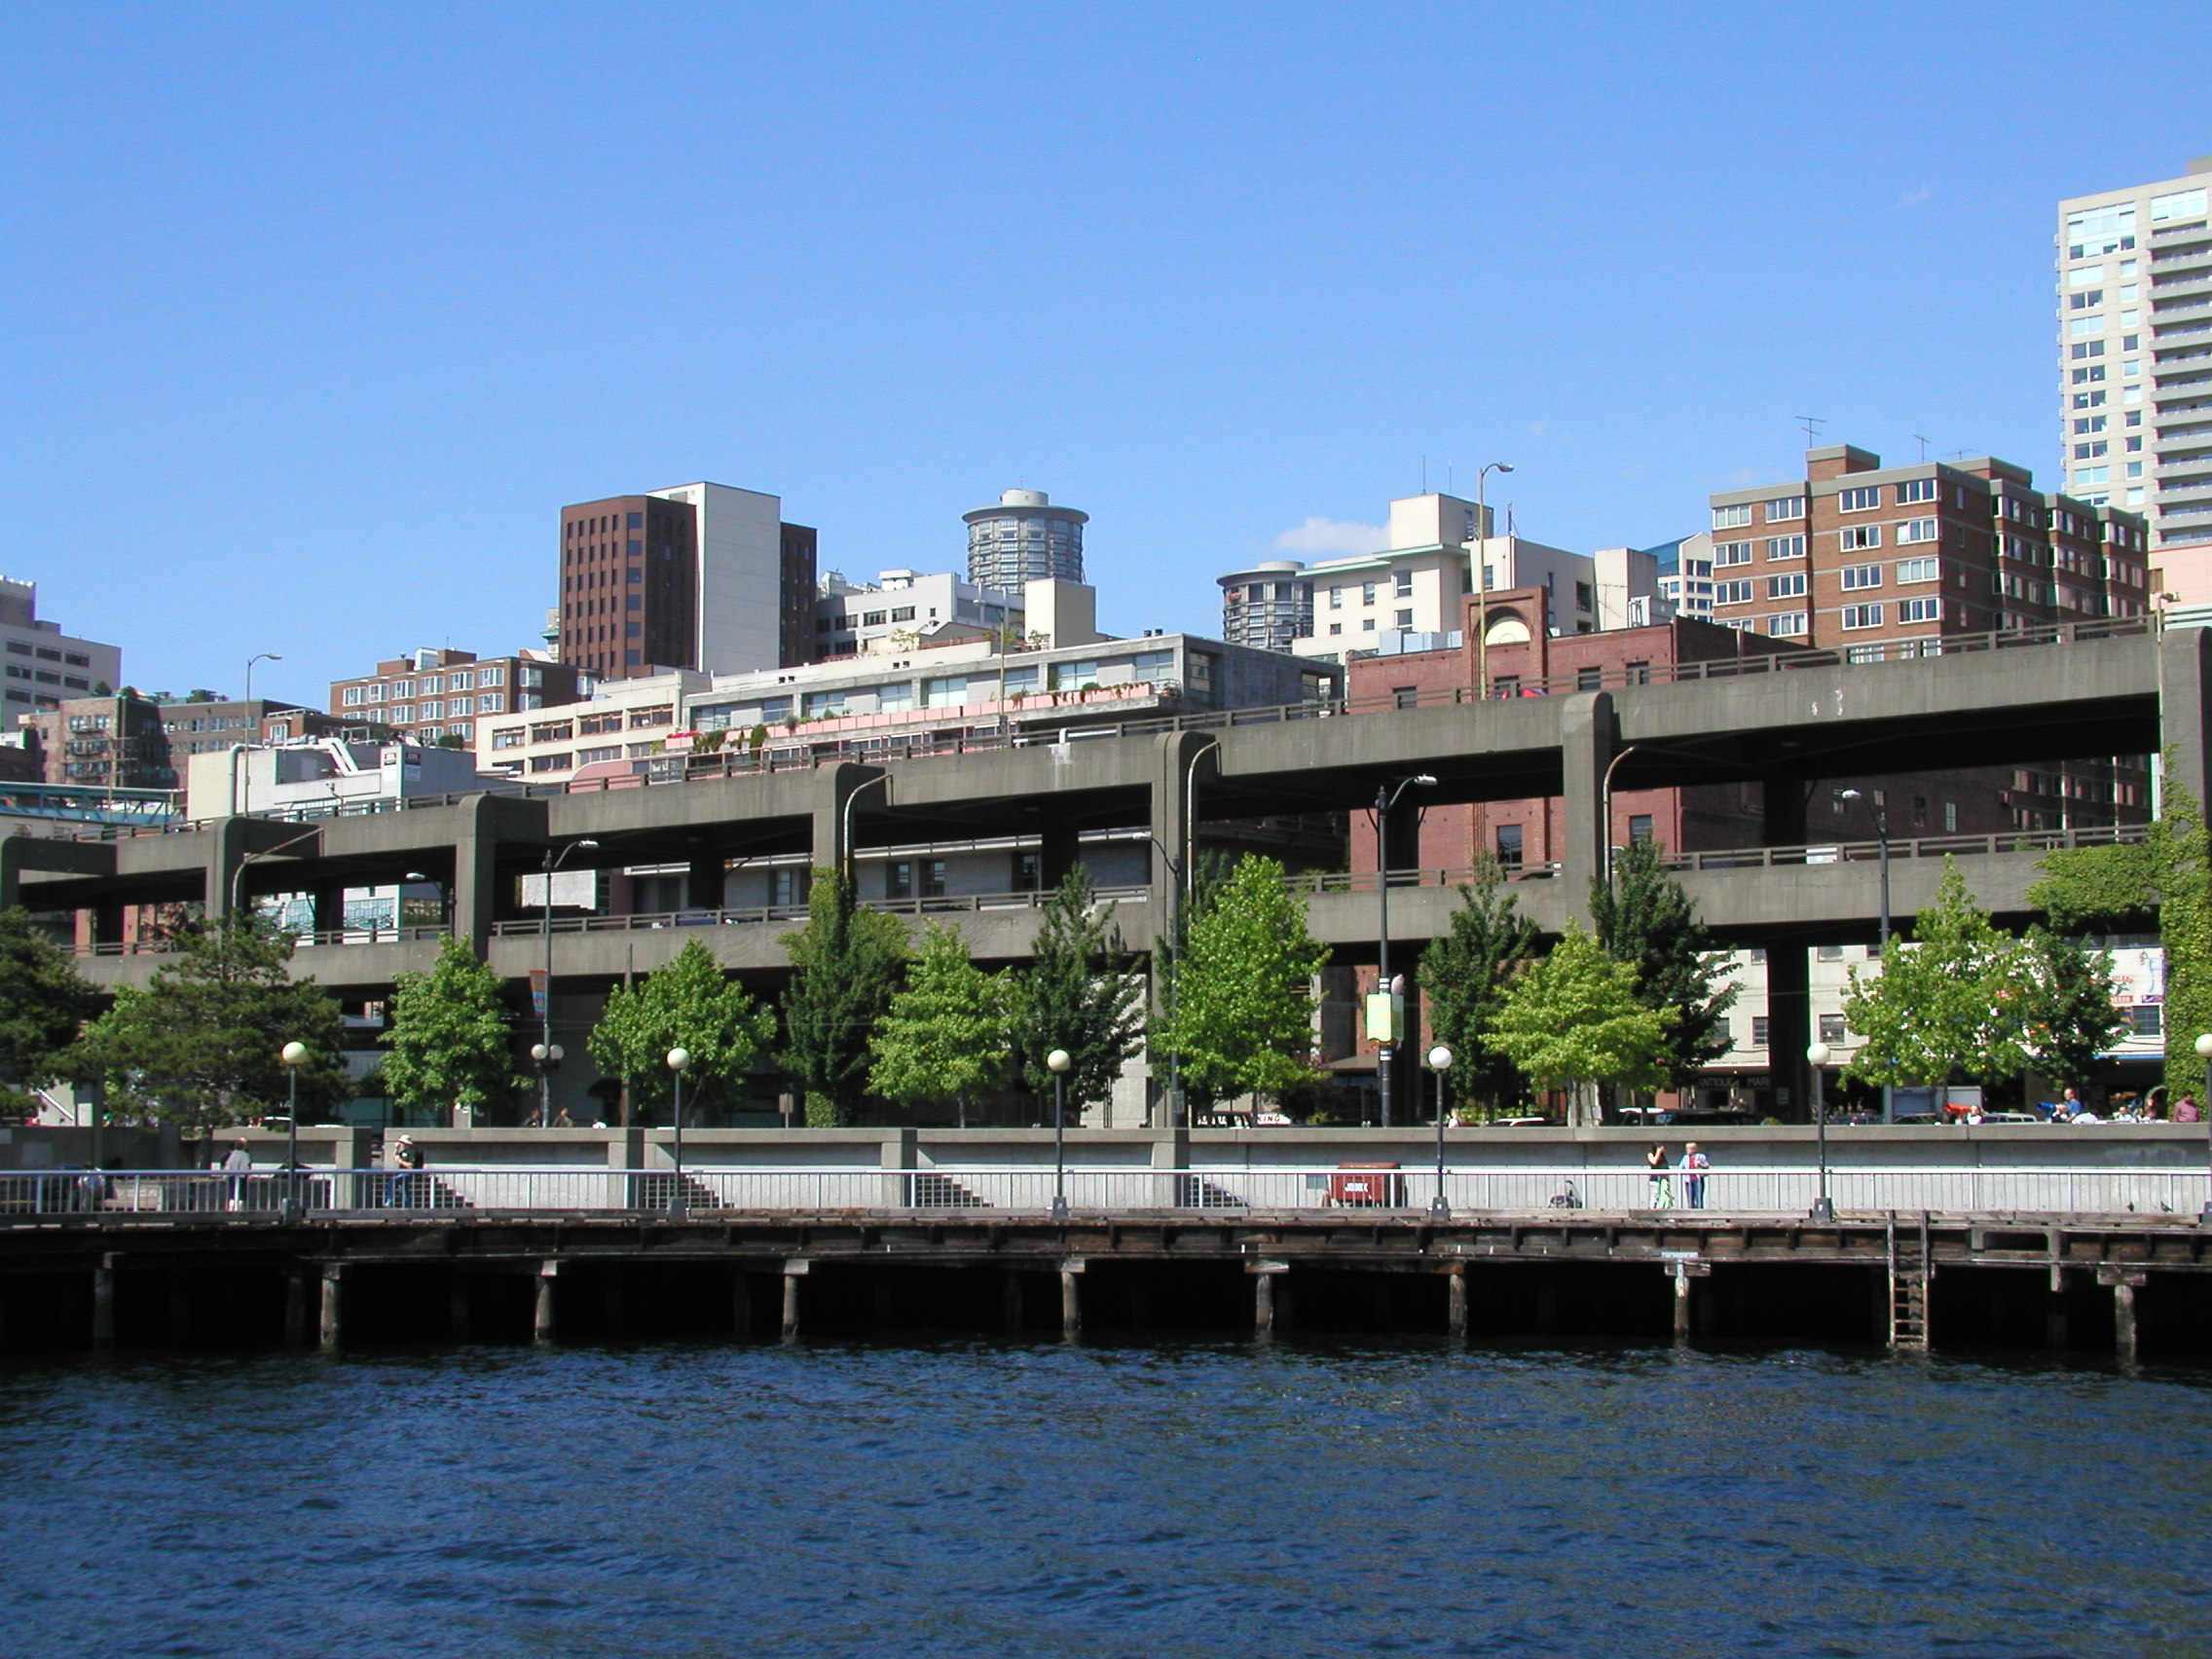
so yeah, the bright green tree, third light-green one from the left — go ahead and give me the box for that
[869,927,1014,1128]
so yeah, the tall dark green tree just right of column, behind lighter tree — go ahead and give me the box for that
[1591,840,1739,1088]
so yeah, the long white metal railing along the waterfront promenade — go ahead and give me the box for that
[0,1163,2212,1221]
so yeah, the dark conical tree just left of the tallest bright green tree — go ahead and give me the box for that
[1014,865,1144,1115]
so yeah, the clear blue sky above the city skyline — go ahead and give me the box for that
[0,0,2212,703]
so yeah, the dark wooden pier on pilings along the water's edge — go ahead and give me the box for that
[0,1210,2212,1360]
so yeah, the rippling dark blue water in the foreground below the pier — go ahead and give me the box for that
[0,1345,2212,1659]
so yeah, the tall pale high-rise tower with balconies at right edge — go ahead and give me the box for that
[2057,155,2212,604]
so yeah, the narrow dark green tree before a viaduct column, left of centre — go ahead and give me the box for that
[783,869,907,1124]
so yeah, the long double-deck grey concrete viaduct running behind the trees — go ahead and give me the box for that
[25,631,2212,1096]
